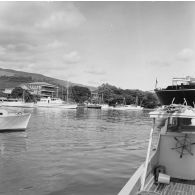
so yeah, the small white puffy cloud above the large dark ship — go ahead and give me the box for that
[176,48,195,61]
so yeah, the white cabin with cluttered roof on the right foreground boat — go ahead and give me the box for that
[150,105,195,184]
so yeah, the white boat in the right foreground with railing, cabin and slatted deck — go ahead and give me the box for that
[118,105,195,195]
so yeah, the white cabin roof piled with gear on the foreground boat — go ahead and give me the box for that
[149,104,195,119]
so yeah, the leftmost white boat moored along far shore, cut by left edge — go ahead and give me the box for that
[0,98,34,108]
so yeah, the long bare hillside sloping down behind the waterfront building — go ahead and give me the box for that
[0,68,96,90]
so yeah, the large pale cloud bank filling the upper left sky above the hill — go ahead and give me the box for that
[0,2,86,75]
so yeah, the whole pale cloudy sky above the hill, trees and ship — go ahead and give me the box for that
[0,1,195,91]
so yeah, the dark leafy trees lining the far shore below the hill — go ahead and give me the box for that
[7,84,160,108]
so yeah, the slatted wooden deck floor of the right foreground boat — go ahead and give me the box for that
[150,179,195,195]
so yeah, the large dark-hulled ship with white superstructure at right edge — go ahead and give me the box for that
[154,76,195,107]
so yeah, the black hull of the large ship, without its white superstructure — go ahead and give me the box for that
[155,89,195,107]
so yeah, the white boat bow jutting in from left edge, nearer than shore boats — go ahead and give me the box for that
[0,109,31,132]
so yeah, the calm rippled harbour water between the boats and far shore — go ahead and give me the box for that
[0,108,154,195]
